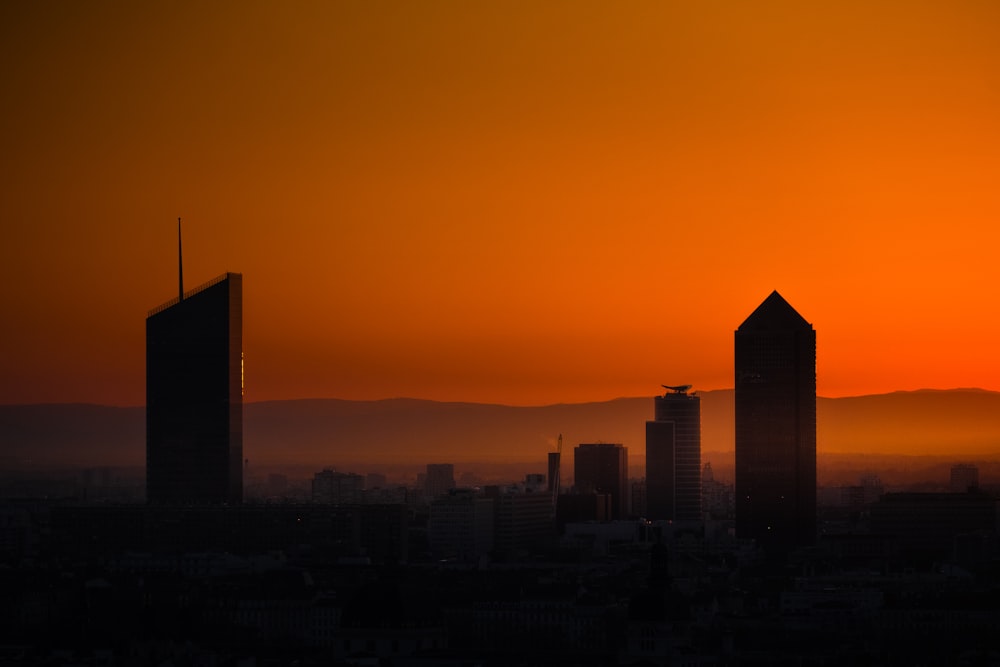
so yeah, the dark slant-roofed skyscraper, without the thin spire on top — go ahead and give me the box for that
[146,273,243,505]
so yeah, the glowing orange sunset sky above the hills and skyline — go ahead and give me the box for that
[0,0,1000,405]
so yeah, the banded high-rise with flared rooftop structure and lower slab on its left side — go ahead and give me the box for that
[646,385,701,521]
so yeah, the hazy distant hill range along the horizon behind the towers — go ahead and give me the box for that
[0,389,1000,480]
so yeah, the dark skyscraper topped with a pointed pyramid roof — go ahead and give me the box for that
[735,292,816,550]
